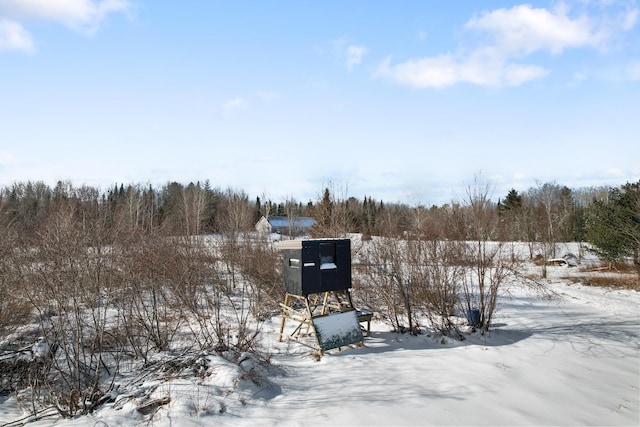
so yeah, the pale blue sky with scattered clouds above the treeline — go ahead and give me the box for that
[0,0,640,204]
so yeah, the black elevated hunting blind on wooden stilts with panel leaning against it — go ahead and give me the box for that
[279,239,372,354]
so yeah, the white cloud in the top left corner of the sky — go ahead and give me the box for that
[0,0,133,52]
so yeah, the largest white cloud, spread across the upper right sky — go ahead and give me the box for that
[374,3,637,88]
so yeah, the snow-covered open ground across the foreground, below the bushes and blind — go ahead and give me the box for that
[0,258,640,426]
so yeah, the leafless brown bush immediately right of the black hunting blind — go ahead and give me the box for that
[356,238,467,336]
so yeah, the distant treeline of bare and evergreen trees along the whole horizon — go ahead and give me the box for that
[0,181,639,249]
